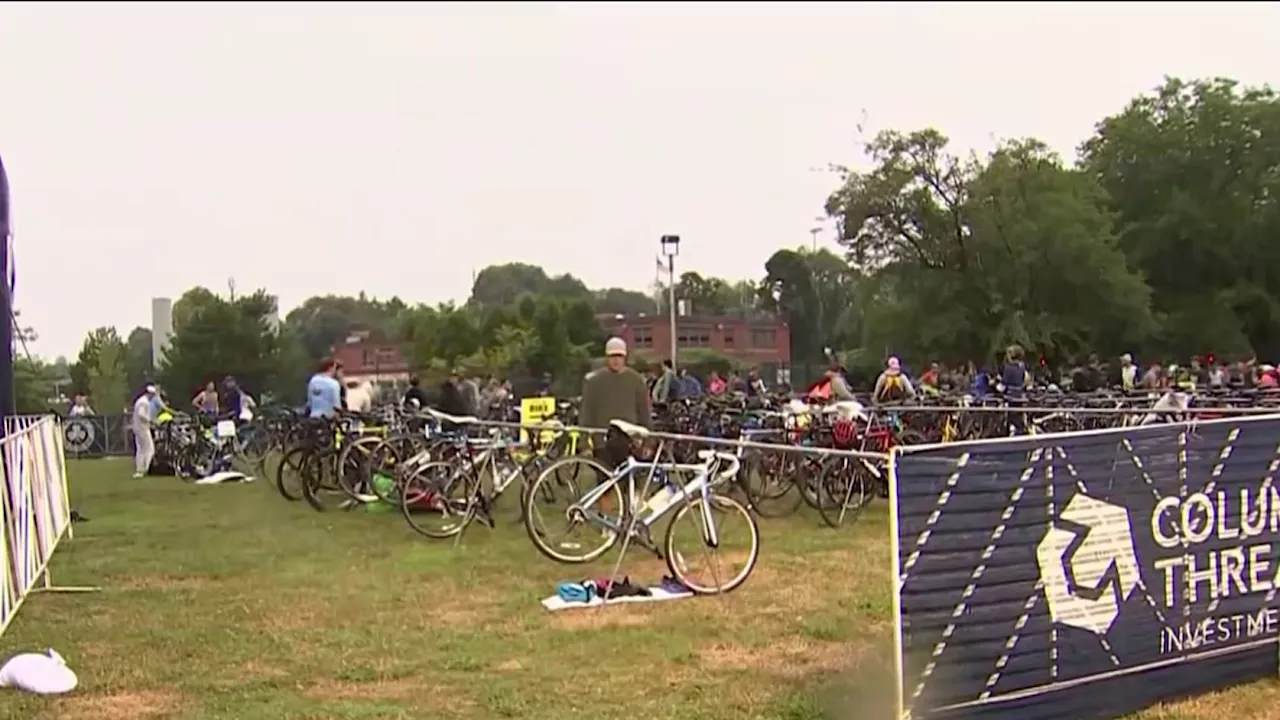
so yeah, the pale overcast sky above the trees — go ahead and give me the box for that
[0,3,1280,357]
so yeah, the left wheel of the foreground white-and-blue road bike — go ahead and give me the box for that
[525,456,623,565]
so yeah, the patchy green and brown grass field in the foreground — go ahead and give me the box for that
[0,460,1280,720]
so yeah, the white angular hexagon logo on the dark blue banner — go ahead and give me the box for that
[1036,493,1142,635]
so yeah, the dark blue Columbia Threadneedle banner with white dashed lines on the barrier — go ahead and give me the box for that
[893,416,1280,720]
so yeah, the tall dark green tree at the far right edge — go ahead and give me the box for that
[1080,79,1280,357]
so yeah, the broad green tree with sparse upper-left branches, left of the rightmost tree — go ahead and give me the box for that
[824,129,1155,360]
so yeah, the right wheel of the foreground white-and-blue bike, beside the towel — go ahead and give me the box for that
[663,495,760,594]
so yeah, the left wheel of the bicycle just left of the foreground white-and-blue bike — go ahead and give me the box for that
[399,461,476,539]
